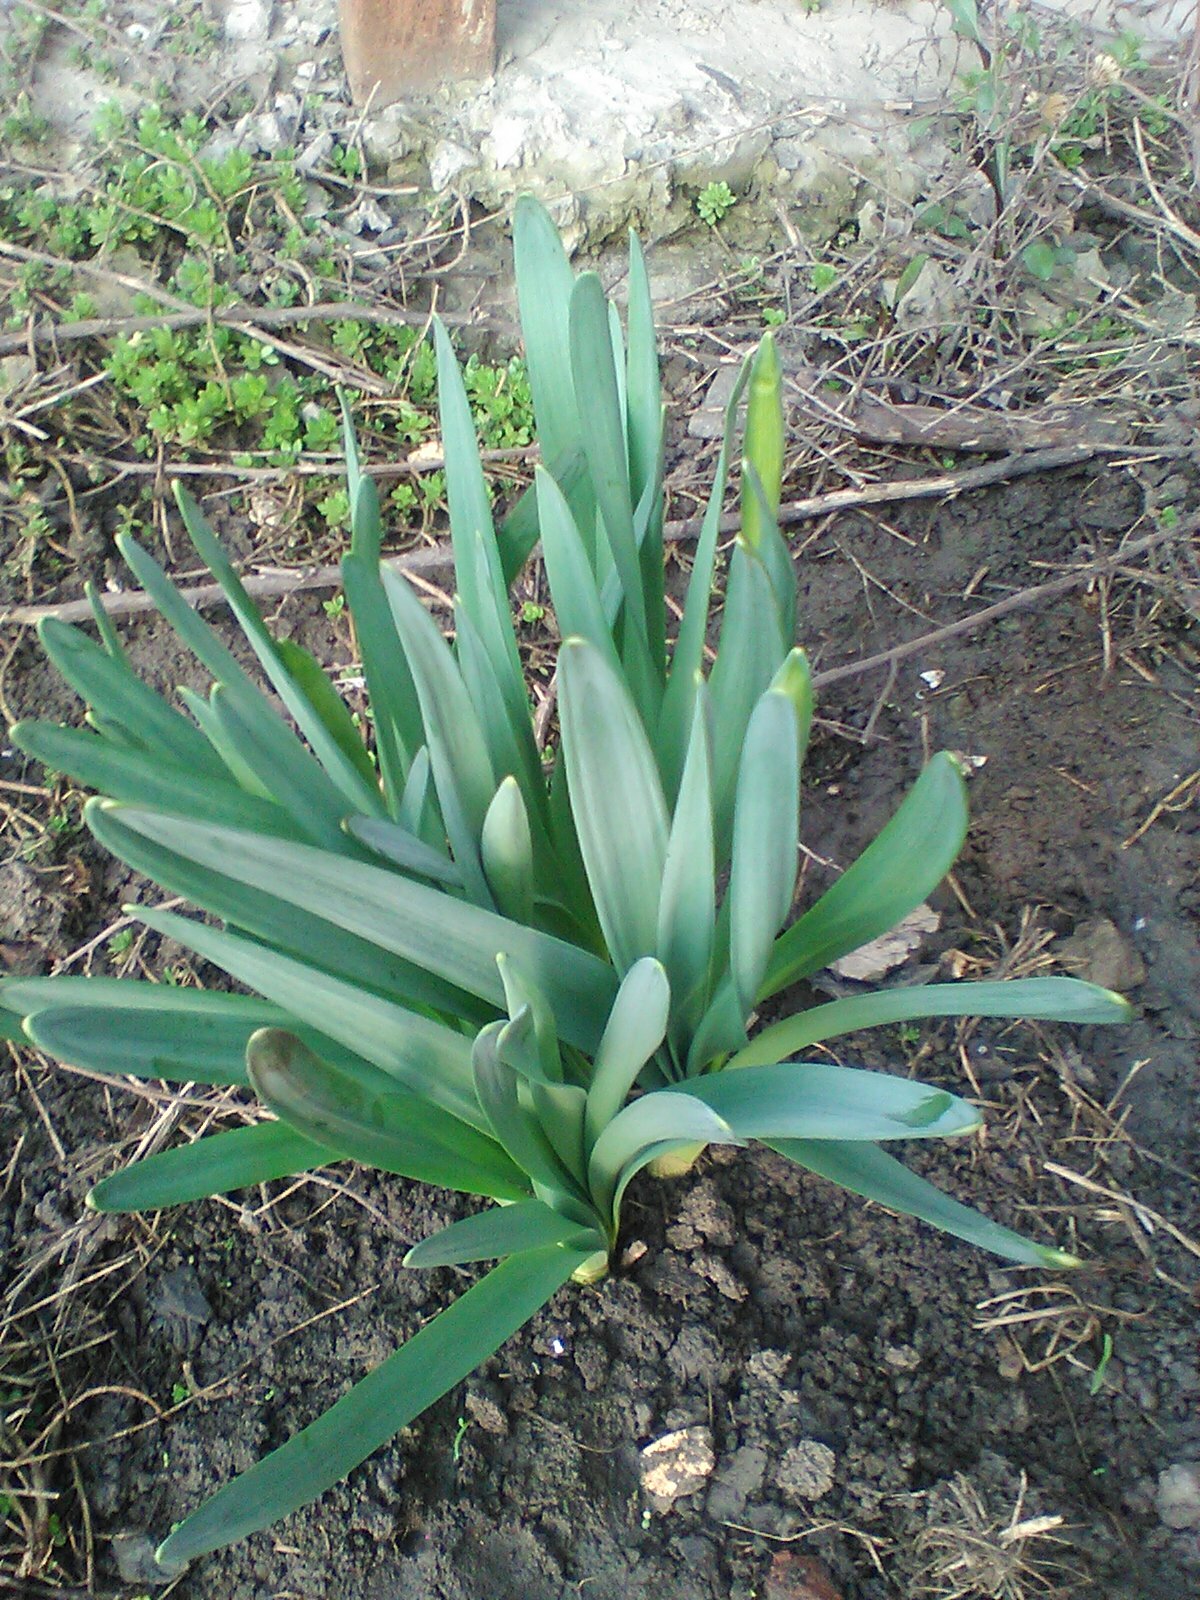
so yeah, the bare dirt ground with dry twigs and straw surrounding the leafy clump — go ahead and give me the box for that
[0,3,1200,1600]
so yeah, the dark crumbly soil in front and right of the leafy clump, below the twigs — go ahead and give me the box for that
[0,438,1200,1600]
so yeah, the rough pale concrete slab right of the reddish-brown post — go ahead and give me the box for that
[309,0,1194,245]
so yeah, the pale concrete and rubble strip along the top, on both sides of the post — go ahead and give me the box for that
[9,0,1195,251]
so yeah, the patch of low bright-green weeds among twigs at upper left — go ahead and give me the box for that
[0,103,533,537]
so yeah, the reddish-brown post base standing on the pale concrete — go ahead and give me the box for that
[338,0,496,107]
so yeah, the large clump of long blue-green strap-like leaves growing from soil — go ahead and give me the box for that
[0,202,1128,1571]
